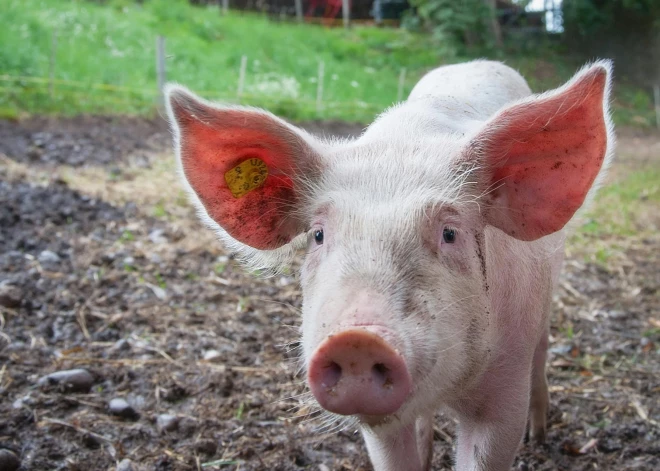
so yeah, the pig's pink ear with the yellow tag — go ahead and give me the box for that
[167,86,321,250]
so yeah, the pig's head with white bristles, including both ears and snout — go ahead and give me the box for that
[168,62,610,436]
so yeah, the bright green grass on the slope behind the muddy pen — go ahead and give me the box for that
[0,0,652,125]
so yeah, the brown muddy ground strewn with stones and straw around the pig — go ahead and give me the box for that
[0,117,660,471]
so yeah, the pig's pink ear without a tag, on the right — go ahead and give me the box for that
[470,61,614,240]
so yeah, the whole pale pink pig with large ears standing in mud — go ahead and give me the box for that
[167,60,614,471]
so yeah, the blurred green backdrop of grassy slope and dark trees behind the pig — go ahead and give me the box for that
[0,0,660,127]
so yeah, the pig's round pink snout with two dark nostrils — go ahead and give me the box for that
[307,328,412,415]
